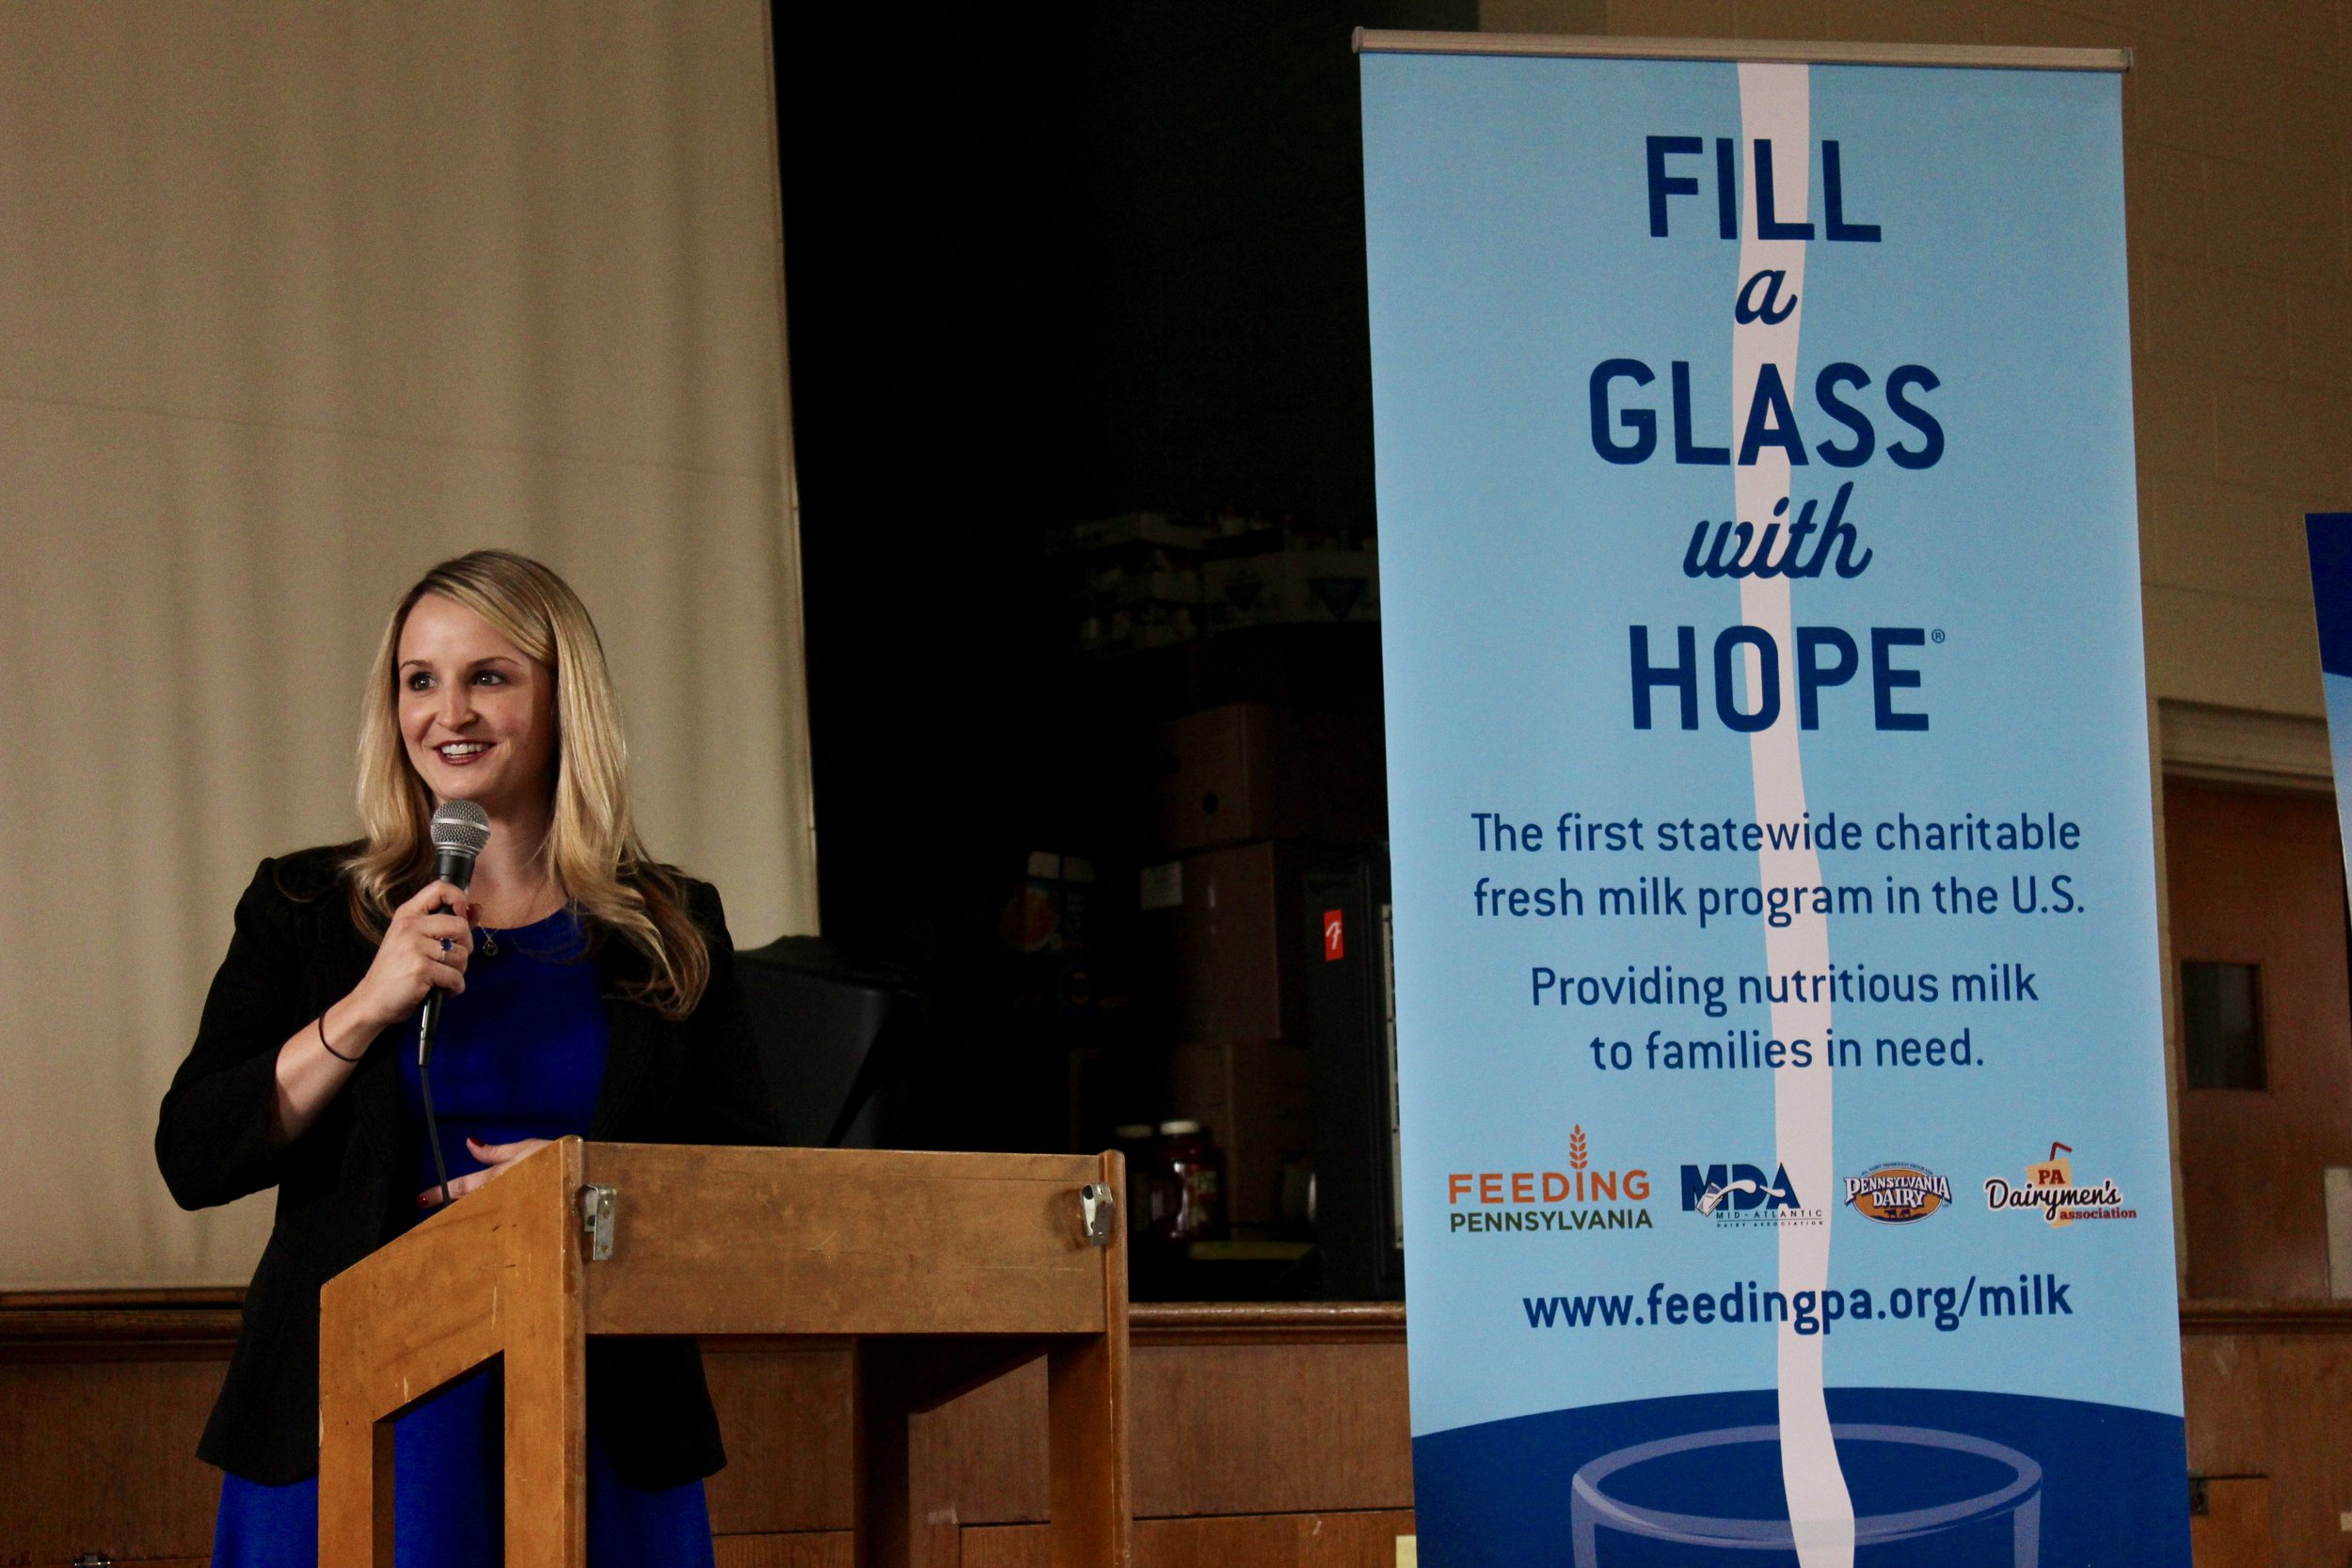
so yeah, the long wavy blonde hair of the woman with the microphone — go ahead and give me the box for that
[346,550,710,1018]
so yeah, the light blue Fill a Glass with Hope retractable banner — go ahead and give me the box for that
[1362,35,2190,1568]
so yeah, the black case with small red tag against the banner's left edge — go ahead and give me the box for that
[1303,851,1405,1300]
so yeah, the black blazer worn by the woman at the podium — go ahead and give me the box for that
[155,847,776,1486]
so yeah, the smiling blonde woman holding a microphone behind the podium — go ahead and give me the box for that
[155,550,771,1568]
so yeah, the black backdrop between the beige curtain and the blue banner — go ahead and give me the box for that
[774,0,1477,1165]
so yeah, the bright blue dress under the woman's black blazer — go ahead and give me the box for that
[212,910,713,1568]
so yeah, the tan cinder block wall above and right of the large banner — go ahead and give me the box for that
[1480,0,2352,717]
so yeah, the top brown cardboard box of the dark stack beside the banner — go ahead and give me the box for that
[1157,703,1388,853]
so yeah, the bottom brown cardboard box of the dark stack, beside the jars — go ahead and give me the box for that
[1169,1039,1315,1232]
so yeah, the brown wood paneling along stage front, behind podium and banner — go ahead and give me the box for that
[13,1300,2352,1568]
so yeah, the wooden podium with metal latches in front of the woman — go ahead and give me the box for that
[318,1138,1129,1568]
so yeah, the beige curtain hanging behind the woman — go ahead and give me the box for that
[0,0,817,1289]
